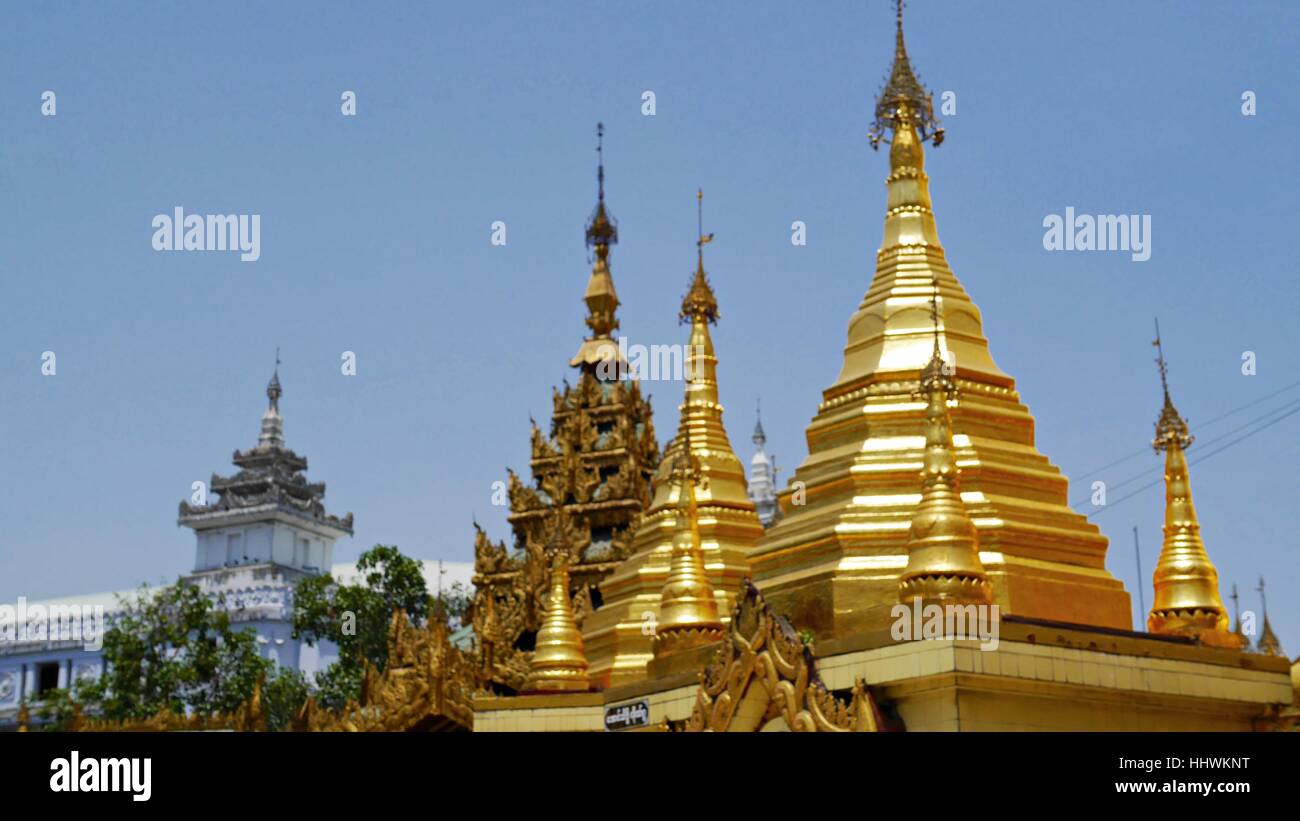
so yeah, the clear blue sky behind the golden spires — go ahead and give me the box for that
[0,0,1300,646]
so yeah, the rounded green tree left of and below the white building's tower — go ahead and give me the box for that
[74,582,272,720]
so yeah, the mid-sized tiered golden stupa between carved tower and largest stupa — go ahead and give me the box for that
[582,192,763,687]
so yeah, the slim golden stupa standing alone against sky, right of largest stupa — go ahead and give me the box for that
[1147,321,1240,647]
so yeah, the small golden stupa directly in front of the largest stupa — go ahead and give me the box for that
[898,282,993,604]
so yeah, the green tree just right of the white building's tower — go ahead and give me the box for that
[294,544,429,709]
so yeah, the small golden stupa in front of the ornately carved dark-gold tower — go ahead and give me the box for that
[524,513,592,692]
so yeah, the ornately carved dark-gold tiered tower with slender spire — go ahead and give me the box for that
[471,126,659,692]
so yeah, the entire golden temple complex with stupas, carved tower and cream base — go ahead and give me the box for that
[302,0,1297,731]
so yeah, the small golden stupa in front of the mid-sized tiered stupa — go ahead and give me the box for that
[655,427,723,655]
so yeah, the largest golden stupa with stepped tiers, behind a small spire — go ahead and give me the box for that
[753,6,1131,637]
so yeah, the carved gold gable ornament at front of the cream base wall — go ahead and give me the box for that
[686,579,880,733]
